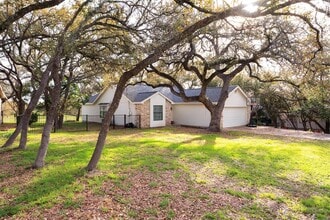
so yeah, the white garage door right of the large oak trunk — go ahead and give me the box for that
[223,107,248,128]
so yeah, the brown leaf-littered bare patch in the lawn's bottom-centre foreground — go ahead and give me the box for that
[19,170,248,219]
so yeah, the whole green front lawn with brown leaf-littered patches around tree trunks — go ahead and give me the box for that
[0,128,330,219]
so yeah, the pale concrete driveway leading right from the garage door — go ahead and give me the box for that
[225,126,330,141]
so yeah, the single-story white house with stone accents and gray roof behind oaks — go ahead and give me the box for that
[81,84,250,128]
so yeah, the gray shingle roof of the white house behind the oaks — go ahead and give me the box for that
[88,84,237,103]
